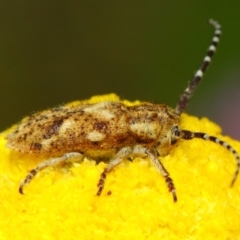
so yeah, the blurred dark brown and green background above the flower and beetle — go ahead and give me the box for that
[0,0,240,139]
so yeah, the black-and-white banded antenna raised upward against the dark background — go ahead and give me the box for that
[175,19,222,115]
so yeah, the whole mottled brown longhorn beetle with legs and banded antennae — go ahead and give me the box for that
[7,19,240,202]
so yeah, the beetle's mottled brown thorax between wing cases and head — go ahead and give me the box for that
[129,103,179,152]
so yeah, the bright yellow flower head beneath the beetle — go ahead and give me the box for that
[0,94,240,240]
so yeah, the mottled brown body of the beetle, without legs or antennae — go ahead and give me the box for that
[7,102,179,155]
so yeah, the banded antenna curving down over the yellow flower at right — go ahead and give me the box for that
[180,130,240,187]
